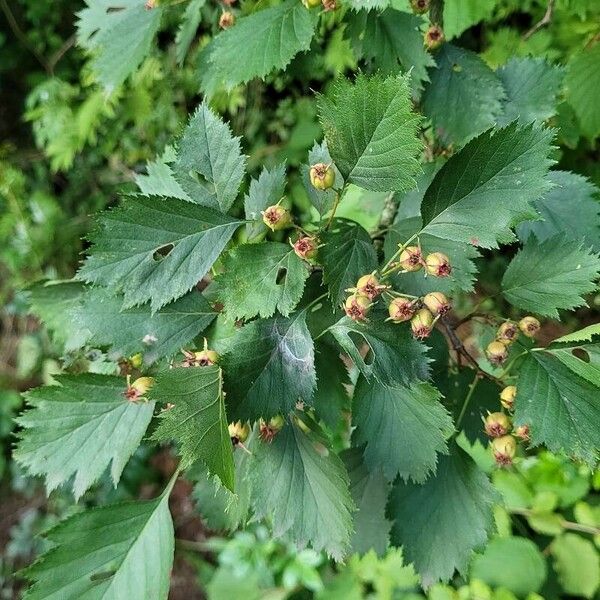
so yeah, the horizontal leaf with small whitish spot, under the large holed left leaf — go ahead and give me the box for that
[69,287,217,364]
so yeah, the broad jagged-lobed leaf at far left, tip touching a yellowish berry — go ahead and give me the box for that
[14,374,154,499]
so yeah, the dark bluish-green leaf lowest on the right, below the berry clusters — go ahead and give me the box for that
[388,444,497,587]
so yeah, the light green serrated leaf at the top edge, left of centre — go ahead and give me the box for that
[203,0,317,89]
